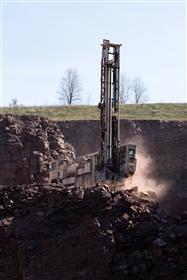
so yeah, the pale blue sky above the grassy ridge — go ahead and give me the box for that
[1,1,187,106]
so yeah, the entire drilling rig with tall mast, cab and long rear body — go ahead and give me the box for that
[47,39,136,186]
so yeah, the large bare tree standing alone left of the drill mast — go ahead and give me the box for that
[59,68,82,105]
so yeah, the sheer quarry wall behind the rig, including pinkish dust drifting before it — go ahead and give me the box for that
[59,120,187,210]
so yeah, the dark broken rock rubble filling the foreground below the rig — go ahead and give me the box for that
[0,184,187,280]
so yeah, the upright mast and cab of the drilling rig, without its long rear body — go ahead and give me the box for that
[99,40,136,179]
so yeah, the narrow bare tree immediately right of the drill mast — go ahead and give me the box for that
[120,74,131,104]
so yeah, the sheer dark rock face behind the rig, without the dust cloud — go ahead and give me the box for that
[59,120,187,184]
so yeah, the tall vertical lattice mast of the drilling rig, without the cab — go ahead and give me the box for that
[99,40,121,172]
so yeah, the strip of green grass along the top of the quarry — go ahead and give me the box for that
[1,103,187,120]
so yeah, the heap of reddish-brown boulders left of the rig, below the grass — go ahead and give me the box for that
[0,115,74,184]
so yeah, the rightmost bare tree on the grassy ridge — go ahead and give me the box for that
[131,77,149,104]
